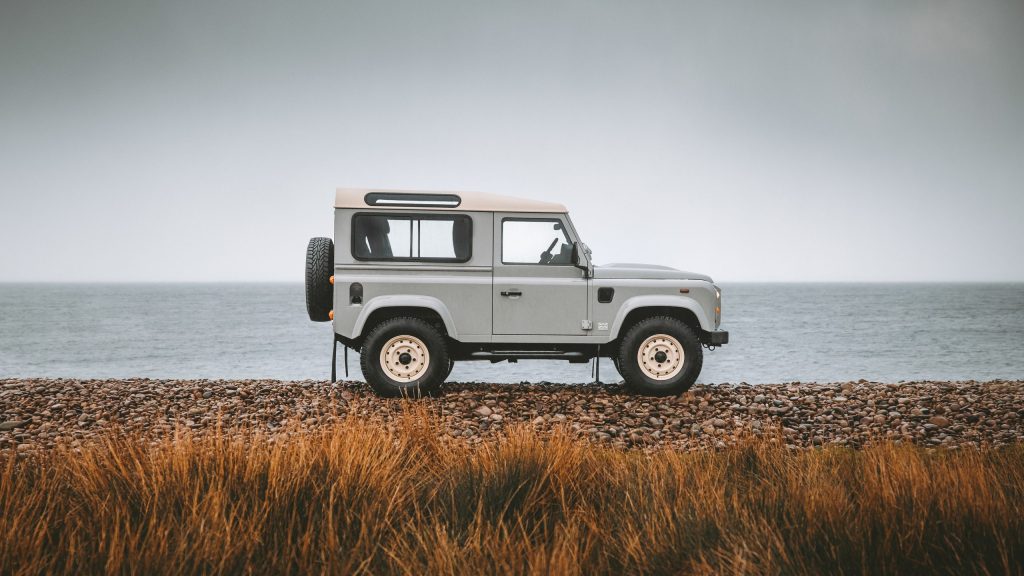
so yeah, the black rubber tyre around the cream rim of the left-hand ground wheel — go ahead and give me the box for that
[359,318,452,398]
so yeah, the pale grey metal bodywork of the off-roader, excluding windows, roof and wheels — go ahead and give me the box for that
[334,209,717,345]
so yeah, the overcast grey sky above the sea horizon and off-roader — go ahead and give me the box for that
[0,0,1024,282]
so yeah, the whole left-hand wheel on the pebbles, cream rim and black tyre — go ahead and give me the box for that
[359,318,451,398]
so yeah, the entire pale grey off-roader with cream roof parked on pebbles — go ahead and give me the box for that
[306,189,728,396]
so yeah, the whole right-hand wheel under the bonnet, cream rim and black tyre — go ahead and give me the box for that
[616,316,703,396]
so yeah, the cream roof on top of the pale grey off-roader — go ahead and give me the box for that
[334,188,568,213]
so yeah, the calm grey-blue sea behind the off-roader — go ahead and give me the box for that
[0,283,1024,384]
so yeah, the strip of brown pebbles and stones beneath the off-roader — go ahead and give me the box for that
[0,379,1024,455]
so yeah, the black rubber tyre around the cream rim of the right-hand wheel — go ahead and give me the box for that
[617,316,703,396]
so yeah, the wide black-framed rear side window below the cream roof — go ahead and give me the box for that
[352,213,473,262]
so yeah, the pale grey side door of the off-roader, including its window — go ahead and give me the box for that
[492,213,588,336]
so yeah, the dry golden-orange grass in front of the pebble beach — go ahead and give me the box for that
[0,407,1024,575]
